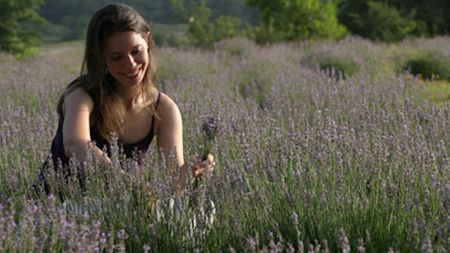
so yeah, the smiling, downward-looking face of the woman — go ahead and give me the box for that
[103,31,149,88]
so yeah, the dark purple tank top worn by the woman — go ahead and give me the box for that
[44,93,161,168]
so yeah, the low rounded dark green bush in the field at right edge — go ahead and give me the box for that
[403,52,450,80]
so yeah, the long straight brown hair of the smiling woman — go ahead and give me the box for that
[58,4,157,140]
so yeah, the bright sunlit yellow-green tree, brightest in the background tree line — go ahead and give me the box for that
[247,0,346,42]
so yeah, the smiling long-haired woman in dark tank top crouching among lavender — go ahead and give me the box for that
[37,4,214,194]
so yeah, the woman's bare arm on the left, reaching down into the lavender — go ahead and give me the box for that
[63,88,111,165]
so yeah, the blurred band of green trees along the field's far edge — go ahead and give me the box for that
[0,0,450,56]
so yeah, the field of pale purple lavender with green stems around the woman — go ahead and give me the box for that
[0,38,450,252]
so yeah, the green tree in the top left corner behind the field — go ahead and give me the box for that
[0,0,45,58]
